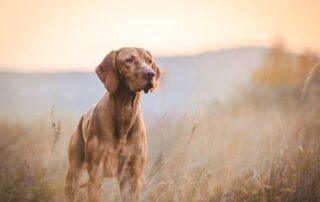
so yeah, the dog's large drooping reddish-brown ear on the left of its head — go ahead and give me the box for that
[96,51,119,93]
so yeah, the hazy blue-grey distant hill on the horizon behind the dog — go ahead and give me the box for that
[0,47,267,123]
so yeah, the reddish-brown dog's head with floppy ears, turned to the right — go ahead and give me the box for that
[96,48,160,93]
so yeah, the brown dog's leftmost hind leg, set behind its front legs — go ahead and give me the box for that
[65,121,85,202]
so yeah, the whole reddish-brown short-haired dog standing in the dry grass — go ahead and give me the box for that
[65,48,160,201]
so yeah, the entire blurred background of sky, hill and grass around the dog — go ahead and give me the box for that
[0,0,320,201]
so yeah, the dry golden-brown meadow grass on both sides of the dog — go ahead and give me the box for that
[0,66,320,201]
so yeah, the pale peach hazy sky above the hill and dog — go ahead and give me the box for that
[0,0,320,71]
